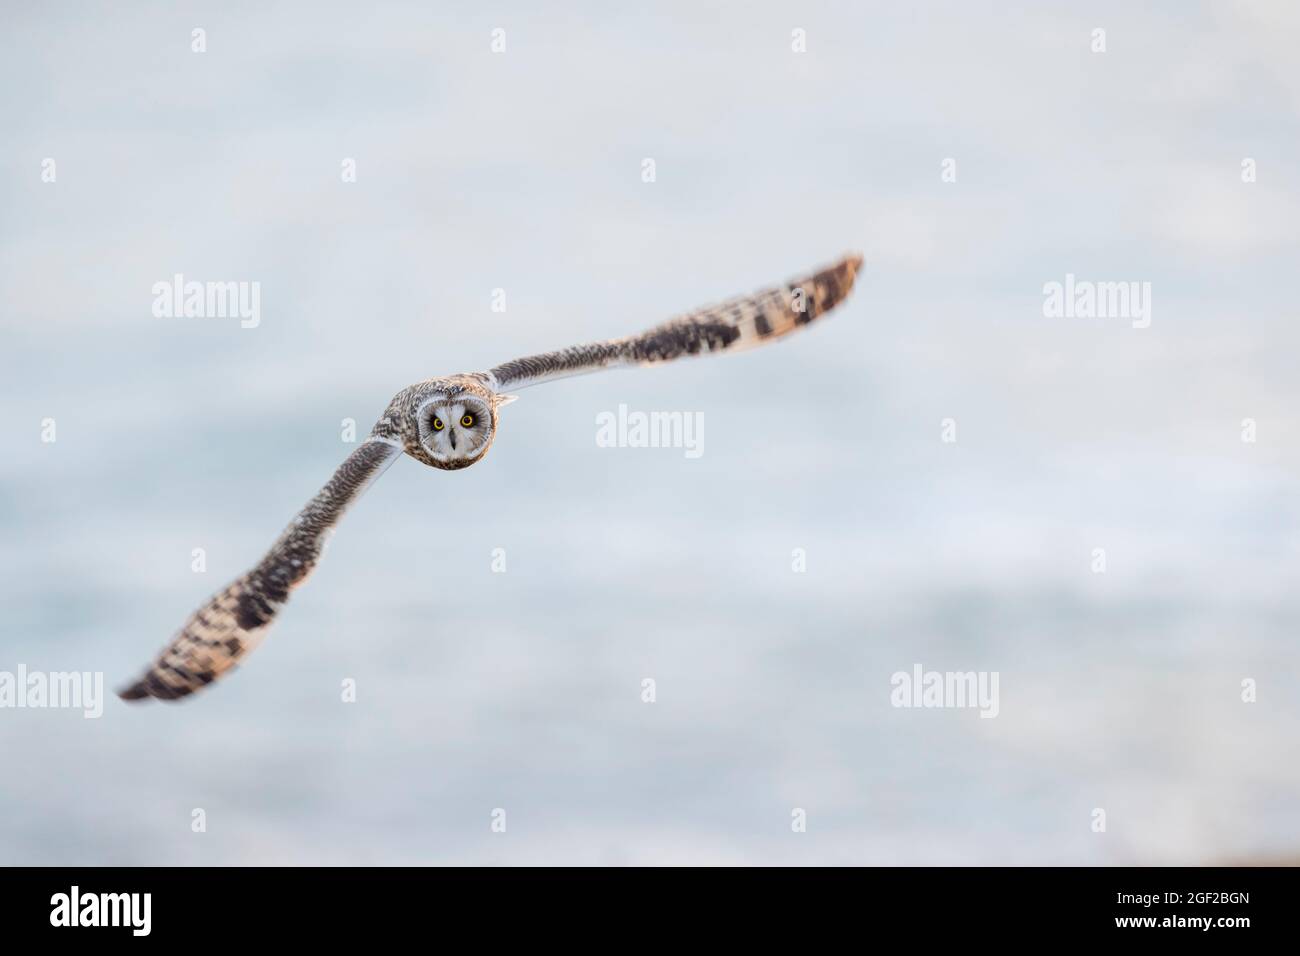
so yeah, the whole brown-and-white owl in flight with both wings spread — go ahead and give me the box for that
[118,255,862,700]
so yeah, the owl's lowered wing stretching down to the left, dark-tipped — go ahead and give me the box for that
[118,438,402,700]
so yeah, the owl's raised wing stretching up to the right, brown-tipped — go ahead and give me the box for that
[482,255,862,392]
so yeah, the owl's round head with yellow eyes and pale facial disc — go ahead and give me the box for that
[403,382,512,471]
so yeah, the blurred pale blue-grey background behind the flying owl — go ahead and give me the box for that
[0,1,1300,864]
